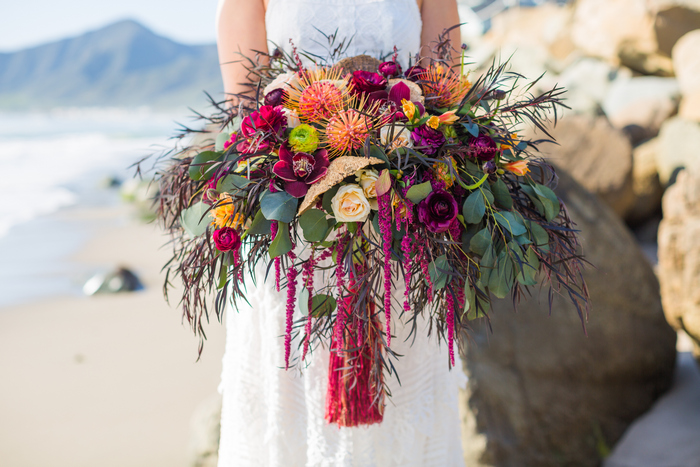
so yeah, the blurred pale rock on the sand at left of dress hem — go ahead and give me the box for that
[189,394,221,467]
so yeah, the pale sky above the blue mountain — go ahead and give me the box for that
[0,0,218,52]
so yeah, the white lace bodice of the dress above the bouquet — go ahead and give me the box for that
[265,0,422,66]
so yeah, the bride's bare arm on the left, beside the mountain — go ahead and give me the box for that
[217,0,267,101]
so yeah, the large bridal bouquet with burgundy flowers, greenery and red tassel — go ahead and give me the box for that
[141,36,587,426]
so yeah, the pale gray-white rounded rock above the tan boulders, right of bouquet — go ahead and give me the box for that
[603,76,680,145]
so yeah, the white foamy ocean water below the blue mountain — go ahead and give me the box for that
[0,108,187,307]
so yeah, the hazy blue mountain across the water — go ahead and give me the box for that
[0,20,223,109]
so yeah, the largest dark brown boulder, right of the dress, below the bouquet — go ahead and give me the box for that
[463,173,676,467]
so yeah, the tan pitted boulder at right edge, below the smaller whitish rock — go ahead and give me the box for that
[659,167,700,359]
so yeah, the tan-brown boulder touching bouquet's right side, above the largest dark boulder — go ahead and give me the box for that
[534,115,635,217]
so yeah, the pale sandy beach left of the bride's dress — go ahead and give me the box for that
[0,206,224,467]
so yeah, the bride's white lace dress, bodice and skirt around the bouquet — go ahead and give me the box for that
[219,0,466,467]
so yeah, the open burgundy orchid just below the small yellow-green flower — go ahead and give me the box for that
[272,143,330,198]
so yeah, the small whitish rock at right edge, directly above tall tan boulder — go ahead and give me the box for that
[656,117,700,186]
